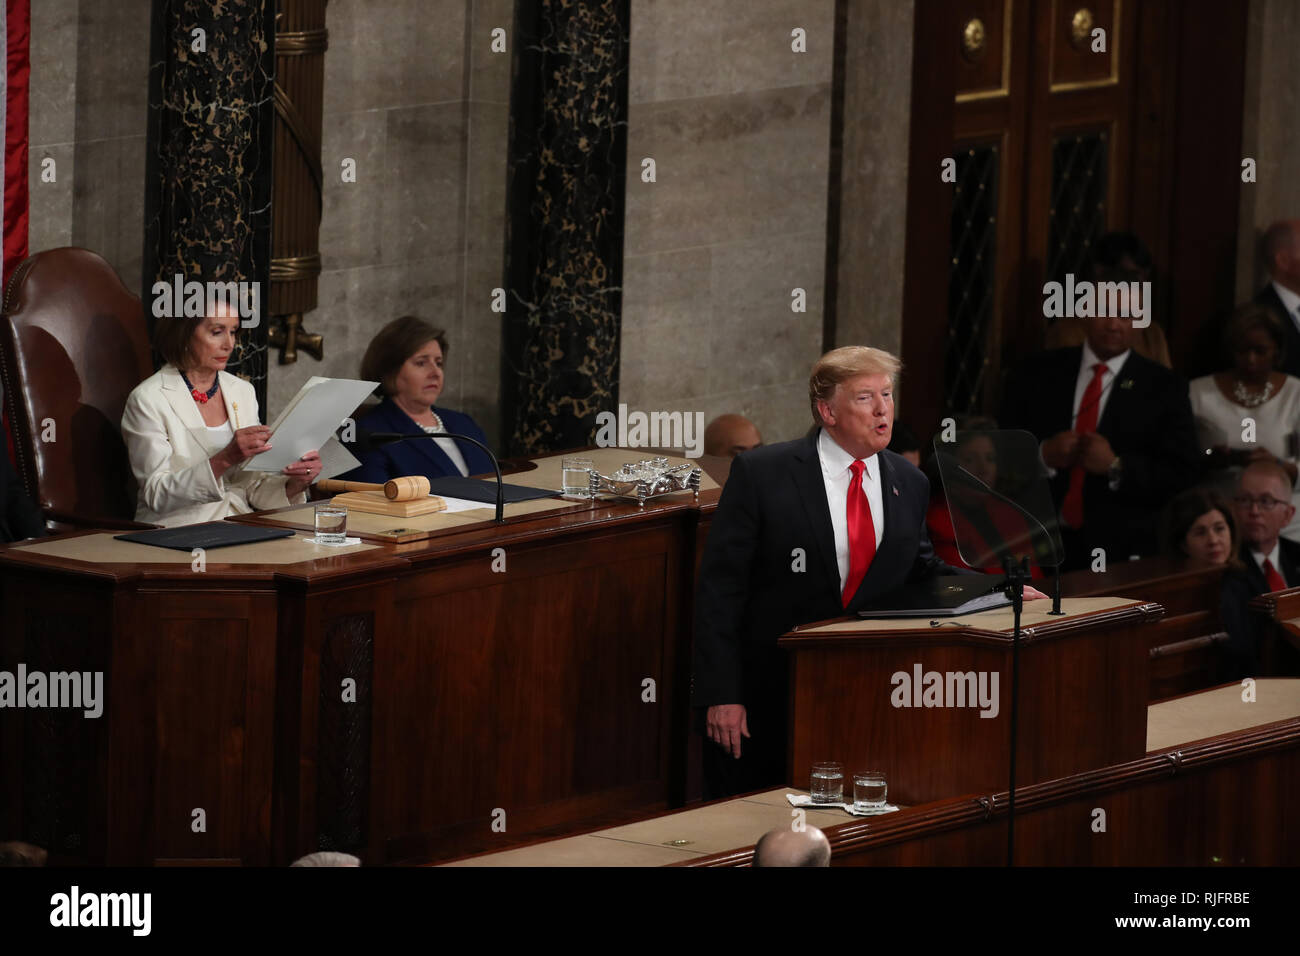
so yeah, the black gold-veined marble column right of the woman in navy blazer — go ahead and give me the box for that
[502,0,629,454]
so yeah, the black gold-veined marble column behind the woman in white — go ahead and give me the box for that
[144,0,276,405]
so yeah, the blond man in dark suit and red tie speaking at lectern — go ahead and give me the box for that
[692,346,1041,797]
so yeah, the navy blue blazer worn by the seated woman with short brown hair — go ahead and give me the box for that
[339,398,494,483]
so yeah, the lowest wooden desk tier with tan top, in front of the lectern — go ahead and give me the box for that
[436,679,1300,866]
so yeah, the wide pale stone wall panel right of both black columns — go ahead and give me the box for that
[619,0,835,442]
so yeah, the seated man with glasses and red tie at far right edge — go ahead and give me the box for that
[1221,460,1300,680]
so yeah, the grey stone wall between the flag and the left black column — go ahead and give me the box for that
[27,0,151,293]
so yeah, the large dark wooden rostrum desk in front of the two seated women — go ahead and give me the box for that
[0,449,718,865]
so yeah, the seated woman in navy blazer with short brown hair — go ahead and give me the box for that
[341,315,493,481]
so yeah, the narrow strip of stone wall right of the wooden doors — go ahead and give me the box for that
[1236,0,1300,302]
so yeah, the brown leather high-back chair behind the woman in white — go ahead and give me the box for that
[0,247,153,531]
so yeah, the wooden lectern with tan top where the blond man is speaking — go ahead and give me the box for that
[780,597,1164,804]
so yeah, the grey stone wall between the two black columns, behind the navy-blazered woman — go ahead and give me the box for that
[270,0,514,441]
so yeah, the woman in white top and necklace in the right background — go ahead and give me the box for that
[1188,303,1300,541]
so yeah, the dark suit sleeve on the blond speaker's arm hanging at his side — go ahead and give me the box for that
[692,455,762,706]
